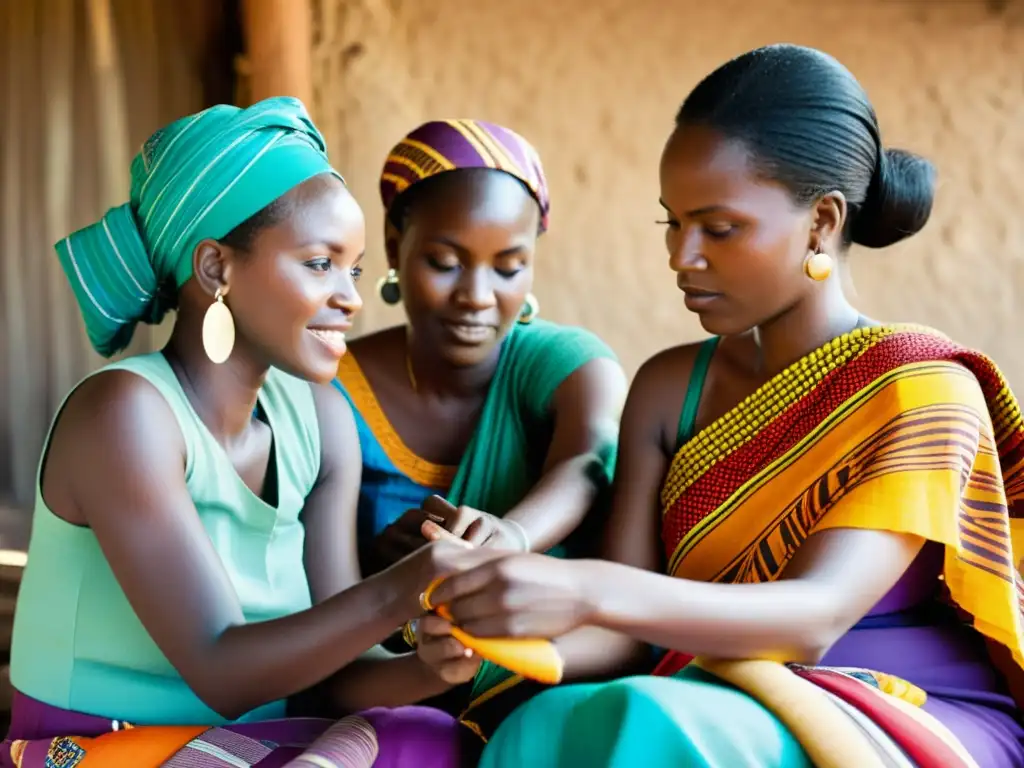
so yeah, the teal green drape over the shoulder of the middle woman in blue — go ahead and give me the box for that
[438,319,618,698]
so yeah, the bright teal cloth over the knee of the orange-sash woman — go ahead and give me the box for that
[479,669,813,768]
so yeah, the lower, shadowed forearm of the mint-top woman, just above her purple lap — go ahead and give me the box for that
[330,647,452,713]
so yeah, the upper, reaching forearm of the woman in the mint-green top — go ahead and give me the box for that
[195,573,411,719]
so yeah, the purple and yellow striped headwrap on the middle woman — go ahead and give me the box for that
[381,120,551,232]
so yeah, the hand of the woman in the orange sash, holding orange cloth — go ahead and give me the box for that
[424,522,598,638]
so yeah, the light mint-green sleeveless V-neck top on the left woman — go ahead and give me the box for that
[11,352,321,725]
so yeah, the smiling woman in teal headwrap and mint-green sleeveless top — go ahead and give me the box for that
[0,98,503,768]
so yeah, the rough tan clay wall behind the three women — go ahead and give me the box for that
[314,0,1024,385]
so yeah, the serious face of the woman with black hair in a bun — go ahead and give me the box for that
[660,125,835,335]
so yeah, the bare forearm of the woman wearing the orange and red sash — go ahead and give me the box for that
[584,561,849,662]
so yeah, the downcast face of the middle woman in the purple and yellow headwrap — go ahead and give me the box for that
[388,169,541,368]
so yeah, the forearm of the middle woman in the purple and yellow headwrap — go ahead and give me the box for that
[505,454,604,552]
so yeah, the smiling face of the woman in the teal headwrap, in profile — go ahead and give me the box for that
[214,175,366,383]
